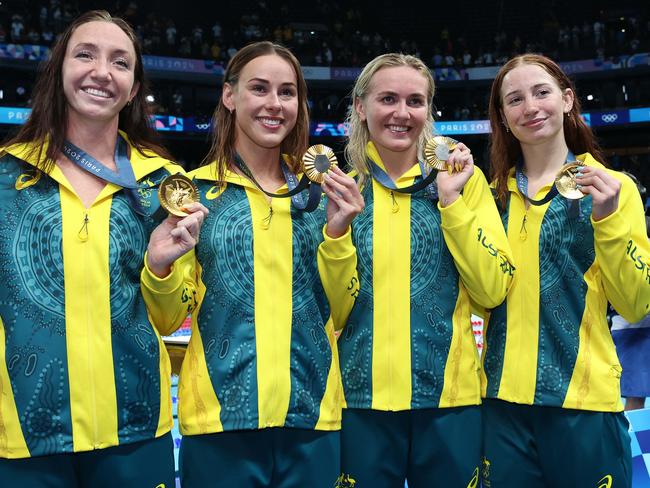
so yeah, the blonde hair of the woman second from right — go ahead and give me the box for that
[345,53,435,184]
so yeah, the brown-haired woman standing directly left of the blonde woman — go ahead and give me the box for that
[179,42,363,488]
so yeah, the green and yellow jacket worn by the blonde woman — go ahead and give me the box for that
[338,143,514,411]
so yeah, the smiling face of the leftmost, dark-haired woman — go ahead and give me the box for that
[62,21,138,127]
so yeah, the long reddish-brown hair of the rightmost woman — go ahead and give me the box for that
[489,53,605,206]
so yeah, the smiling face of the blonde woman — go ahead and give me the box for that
[355,66,429,167]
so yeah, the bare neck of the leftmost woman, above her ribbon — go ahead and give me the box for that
[65,113,118,161]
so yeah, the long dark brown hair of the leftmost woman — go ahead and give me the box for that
[3,10,172,173]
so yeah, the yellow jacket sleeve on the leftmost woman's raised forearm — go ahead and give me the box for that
[140,250,199,335]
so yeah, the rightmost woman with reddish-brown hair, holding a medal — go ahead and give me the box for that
[483,54,650,488]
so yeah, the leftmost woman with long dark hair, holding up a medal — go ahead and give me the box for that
[0,11,206,488]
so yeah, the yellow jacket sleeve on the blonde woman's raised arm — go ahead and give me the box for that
[438,167,515,308]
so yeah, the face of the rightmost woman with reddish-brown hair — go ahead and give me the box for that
[501,64,574,151]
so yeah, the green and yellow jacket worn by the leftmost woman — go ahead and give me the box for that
[0,135,194,458]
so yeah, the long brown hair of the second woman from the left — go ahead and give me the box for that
[203,41,309,182]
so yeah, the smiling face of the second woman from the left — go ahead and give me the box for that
[222,54,299,149]
